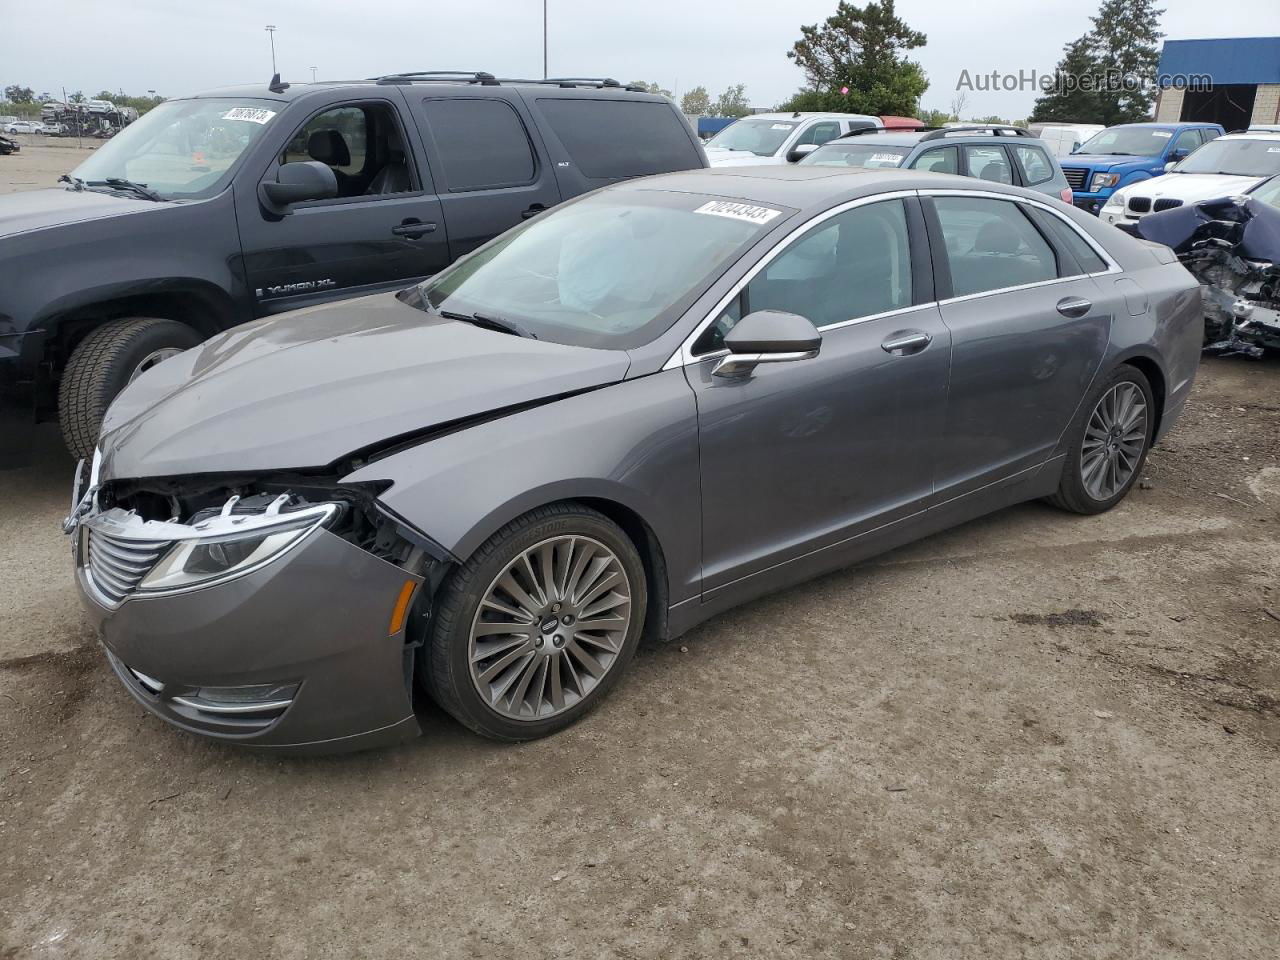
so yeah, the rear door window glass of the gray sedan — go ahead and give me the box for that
[933,197,1059,297]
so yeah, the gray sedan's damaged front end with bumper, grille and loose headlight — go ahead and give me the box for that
[65,458,449,751]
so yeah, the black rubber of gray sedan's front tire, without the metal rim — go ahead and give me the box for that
[417,502,648,742]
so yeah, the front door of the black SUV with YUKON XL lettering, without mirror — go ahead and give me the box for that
[236,92,449,316]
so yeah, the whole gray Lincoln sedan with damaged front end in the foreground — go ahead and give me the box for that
[67,166,1203,750]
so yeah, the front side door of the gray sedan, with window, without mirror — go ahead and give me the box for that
[685,198,950,595]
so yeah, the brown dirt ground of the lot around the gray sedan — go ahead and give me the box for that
[0,144,1280,960]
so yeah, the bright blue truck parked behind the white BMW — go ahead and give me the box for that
[1062,123,1226,214]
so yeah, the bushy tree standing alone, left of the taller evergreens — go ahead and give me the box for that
[782,0,929,115]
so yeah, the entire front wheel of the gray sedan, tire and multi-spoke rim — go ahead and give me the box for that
[419,503,648,741]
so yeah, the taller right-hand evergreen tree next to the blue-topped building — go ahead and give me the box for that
[1089,0,1165,127]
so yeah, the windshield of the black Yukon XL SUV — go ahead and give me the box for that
[72,100,279,200]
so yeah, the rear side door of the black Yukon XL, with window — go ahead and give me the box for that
[408,87,561,260]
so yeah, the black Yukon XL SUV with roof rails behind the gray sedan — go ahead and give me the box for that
[0,72,707,457]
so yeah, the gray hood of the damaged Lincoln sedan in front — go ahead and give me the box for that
[100,293,630,480]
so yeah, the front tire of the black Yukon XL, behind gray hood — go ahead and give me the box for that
[58,317,201,457]
